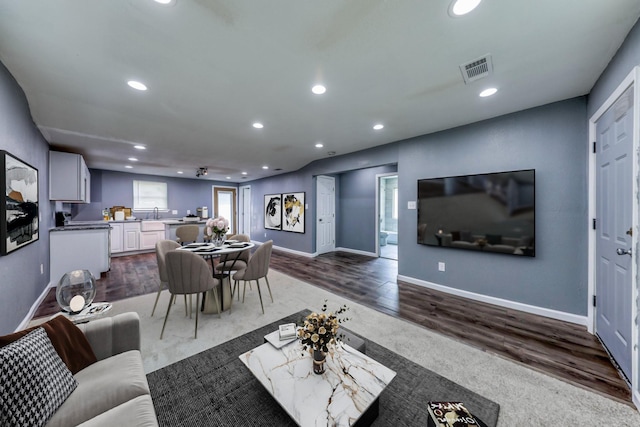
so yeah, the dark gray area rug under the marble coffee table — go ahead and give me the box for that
[147,310,500,427]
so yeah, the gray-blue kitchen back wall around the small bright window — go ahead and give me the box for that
[73,169,232,221]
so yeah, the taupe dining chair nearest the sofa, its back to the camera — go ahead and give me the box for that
[160,251,220,339]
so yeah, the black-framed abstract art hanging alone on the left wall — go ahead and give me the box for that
[0,150,40,255]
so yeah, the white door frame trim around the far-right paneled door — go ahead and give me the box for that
[587,66,640,409]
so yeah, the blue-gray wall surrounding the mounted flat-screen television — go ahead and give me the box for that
[398,97,587,315]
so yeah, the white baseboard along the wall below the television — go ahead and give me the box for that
[398,275,588,327]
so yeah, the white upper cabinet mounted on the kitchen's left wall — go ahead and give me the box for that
[49,151,91,203]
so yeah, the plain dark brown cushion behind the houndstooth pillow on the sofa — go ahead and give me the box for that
[0,316,96,374]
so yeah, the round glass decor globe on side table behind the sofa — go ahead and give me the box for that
[56,270,96,314]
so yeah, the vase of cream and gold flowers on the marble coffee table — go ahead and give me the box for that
[298,300,349,375]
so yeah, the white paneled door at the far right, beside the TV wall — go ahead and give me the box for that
[595,86,634,379]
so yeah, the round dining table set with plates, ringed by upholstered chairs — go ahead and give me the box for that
[176,240,255,313]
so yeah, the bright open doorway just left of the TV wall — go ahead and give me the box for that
[376,173,398,260]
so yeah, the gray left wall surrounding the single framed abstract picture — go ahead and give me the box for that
[0,64,53,334]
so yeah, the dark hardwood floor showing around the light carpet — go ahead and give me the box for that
[34,250,631,404]
